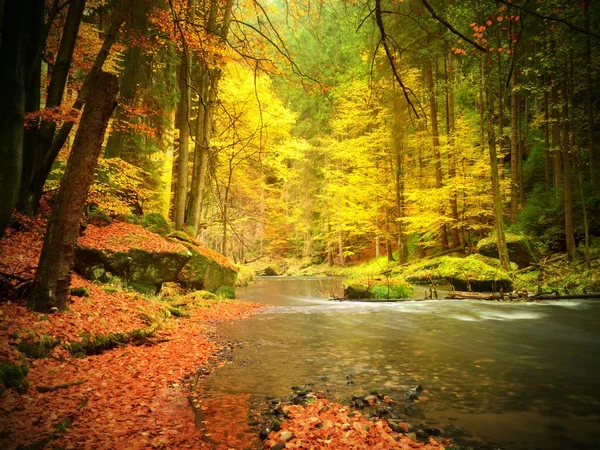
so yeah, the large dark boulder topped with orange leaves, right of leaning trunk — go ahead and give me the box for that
[75,222,190,293]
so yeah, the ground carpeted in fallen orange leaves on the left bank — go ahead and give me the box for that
[0,214,260,449]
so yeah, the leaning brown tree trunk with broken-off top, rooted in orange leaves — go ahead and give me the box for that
[29,72,118,312]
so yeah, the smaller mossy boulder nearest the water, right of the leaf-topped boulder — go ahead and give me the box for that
[169,232,237,297]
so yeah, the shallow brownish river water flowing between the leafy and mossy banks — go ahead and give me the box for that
[205,277,600,450]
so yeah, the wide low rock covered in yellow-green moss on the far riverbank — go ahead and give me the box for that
[402,256,512,292]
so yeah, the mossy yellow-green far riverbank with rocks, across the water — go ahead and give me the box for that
[249,253,600,298]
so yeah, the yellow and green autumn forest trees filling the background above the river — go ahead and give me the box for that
[0,0,600,290]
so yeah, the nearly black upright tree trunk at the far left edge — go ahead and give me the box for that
[0,0,28,237]
